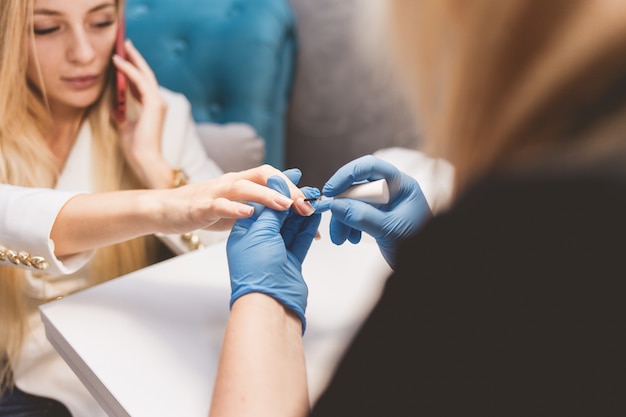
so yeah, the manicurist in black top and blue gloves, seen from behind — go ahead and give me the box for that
[210,0,626,417]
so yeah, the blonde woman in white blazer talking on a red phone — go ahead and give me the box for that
[0,0,312,417]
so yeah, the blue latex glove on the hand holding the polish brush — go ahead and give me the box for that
[318,155,432,268]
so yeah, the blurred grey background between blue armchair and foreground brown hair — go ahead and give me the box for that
[287,0,419,187]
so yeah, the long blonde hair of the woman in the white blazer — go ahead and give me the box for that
[0,0,155,395]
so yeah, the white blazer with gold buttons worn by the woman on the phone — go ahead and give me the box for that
[0,89,228,417]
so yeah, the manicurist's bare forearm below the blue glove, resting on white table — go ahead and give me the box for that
[209,293,309,417]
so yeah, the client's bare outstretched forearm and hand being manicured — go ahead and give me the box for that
[50,166,313,257]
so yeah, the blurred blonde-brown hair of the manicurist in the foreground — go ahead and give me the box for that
[388,0,626,192]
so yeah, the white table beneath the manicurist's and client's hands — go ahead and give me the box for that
[40,214,390,417]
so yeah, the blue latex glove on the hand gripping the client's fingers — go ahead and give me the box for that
[226,173,321,334]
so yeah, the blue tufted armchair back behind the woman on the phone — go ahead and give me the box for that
[126,0,296,169]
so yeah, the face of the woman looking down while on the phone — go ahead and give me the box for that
[27,0,118,114]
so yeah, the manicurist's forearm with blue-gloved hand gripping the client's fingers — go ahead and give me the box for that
[209,177,321,417]
